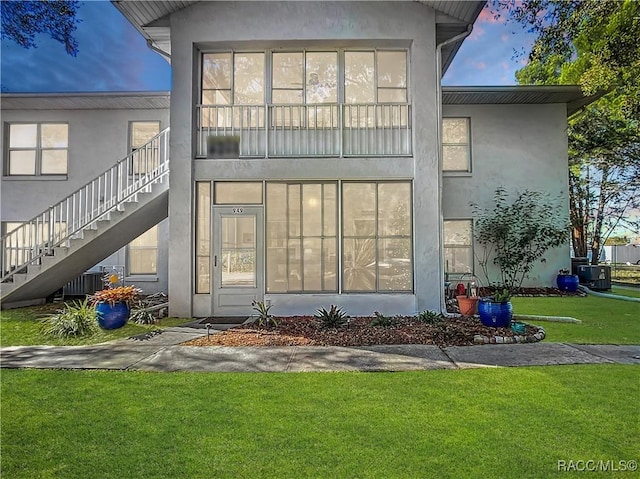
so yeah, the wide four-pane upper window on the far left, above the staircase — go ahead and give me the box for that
[5,123,69,176]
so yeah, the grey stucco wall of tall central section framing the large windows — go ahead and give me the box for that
[169,2,441,316]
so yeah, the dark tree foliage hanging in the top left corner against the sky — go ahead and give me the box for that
[0,0,80,57]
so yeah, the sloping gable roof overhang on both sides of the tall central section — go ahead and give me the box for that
[111,0,486,75]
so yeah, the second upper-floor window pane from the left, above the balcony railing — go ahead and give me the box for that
[233,53,264,105]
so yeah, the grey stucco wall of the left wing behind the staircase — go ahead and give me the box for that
[1,106,169,293]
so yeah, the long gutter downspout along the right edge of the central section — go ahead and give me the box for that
[436,23,473,317]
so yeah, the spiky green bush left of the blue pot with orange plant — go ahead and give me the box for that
[41,299,98,339]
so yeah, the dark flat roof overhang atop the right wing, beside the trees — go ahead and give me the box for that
[442,85,606,117]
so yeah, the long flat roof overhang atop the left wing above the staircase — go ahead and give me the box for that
[0,91,170,110]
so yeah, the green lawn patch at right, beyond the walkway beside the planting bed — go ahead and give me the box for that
[512,296,640,344]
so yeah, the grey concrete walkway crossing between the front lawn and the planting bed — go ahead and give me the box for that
[0,325,640,372]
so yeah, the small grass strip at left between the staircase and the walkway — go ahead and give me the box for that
[0,304,189,347]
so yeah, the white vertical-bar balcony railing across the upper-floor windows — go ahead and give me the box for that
[197,103,412,158]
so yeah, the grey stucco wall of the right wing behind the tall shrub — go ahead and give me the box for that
[442,104,570,286]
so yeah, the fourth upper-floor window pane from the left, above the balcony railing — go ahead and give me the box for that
[306,52,338,103]
